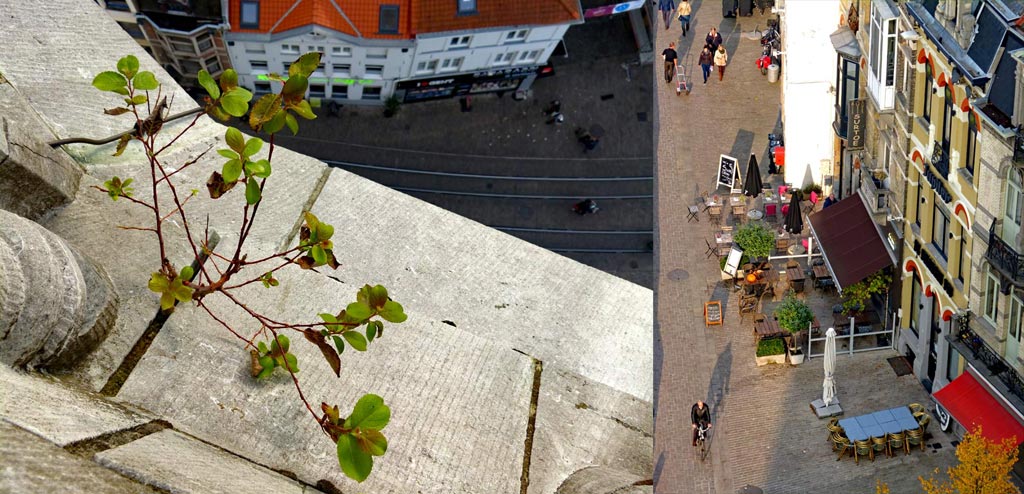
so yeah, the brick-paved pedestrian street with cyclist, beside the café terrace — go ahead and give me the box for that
[652,0,953,494]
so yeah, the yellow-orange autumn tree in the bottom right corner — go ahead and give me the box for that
[918,425,1020,494]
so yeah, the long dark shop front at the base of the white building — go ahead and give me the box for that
[395,65,554,102]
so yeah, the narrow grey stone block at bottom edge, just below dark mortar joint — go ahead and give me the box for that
[95,430,319,494]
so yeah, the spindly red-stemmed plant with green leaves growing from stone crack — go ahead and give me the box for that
[92,53,406,482]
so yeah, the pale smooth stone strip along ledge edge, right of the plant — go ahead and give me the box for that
[312,170,653,401]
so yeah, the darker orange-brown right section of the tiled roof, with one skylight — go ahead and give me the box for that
[413,0,583,33]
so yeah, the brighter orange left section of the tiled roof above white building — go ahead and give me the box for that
[227,0,411,39]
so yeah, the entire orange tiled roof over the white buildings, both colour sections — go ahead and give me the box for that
[227,0,583,39]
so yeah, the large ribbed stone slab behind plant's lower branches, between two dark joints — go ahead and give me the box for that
[119,270,532,493]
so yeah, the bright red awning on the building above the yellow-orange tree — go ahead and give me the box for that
[935,372,1024,445]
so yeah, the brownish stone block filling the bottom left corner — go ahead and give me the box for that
[0,420,158,494]
